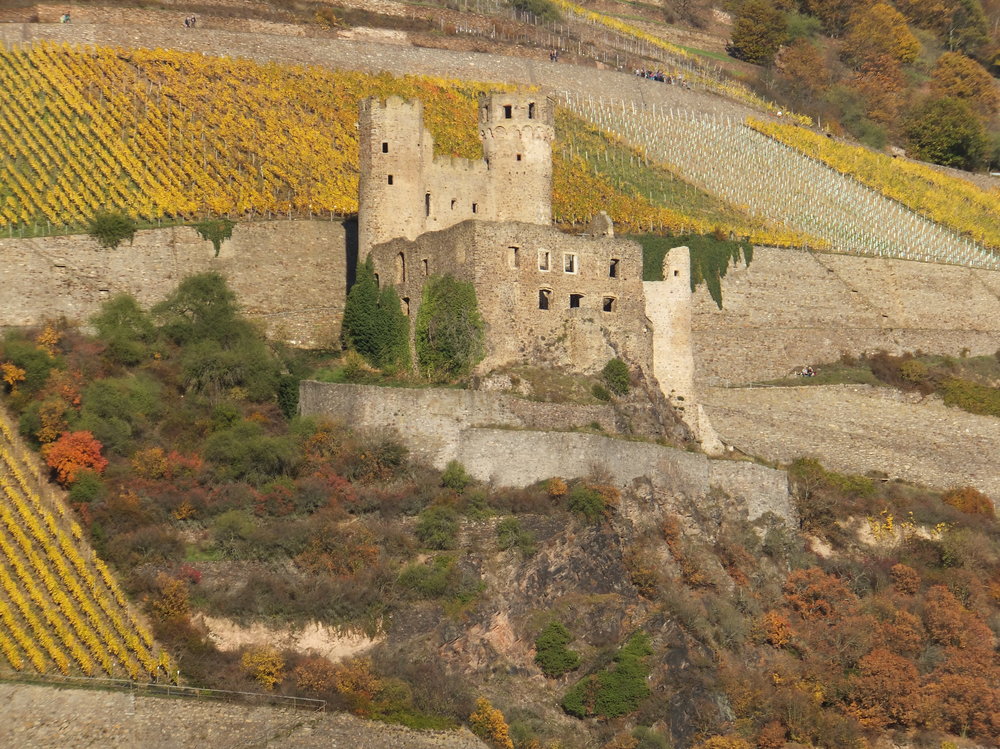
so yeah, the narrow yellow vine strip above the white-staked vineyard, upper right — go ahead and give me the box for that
[747,118,1000,250]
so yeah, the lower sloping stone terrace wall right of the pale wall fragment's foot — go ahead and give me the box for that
[704,385,1000,501]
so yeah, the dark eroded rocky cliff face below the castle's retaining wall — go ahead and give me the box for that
[372,475,787,746]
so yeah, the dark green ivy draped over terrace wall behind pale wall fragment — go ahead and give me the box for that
[633,234,753,309]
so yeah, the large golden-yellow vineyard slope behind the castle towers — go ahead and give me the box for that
[0,43,822,247]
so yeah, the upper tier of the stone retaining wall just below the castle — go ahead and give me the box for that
[299,381,623,468]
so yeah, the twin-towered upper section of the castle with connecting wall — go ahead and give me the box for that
[358,93,555,257]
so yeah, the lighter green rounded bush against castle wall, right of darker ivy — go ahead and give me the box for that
[415,276,486,380]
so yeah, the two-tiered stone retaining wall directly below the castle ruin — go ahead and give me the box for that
[299,382,795,520]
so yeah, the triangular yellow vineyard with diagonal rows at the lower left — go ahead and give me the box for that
[0,414,172,680]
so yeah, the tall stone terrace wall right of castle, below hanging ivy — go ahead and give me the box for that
[692,248,1000,384]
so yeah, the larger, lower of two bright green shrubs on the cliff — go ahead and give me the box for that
[562,632,653,718]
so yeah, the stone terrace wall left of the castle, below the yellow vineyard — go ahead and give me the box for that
[0,216,347,345]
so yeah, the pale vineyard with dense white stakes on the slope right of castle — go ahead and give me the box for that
[563,95,1000,269]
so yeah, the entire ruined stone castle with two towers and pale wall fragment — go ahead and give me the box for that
[358,93,721,452]
